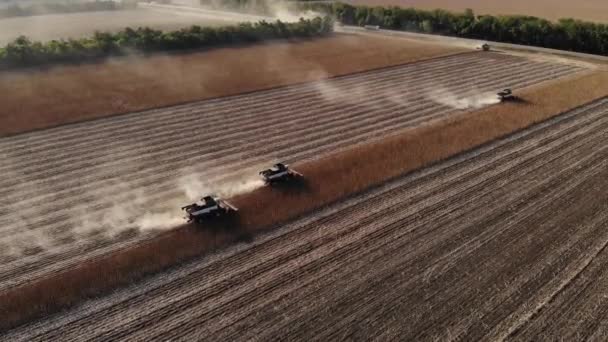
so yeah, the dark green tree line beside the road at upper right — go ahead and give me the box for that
[298,1,608,55]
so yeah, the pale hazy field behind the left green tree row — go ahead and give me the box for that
[0,9,236,45]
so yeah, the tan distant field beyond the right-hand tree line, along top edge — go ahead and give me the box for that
[346,0,608,22]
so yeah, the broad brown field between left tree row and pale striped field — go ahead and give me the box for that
[0,35,465,135]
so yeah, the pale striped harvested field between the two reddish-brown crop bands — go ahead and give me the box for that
[0,54,580,288]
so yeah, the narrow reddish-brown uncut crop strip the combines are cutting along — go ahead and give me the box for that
[0,67,608,328]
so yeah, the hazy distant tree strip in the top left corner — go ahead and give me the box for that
[0,0,137,18]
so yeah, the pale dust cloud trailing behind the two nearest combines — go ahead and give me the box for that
[0,158,270,258]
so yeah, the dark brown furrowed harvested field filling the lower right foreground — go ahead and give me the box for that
[1,98,608,341]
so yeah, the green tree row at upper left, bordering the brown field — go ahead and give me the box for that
[0,17,333,68]
